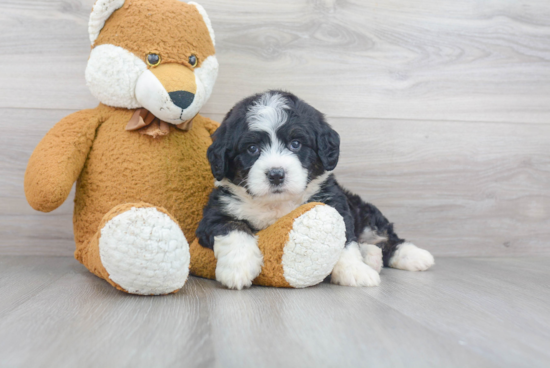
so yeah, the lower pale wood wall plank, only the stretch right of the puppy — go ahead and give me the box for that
[330,115,550,256]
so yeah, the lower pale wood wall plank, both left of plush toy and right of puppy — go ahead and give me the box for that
[0,109,550,256]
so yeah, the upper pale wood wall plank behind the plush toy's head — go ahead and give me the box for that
[0,0,550,123]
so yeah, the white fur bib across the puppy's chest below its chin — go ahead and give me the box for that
[216,172,330,230]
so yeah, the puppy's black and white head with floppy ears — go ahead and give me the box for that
[208,91,340,198]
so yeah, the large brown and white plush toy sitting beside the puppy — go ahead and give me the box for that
[25,0,345,295]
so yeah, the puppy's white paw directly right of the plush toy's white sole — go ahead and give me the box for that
[330,243,380,286]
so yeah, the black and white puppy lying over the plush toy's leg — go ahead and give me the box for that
[197,91,434,289]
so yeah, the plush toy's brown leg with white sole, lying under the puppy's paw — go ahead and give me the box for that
[191,203,346,288]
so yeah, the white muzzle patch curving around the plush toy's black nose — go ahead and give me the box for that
[135,56,218,124]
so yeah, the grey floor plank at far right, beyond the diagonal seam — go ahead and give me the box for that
[368,258,550,367]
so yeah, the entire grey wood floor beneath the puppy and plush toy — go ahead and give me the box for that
[0,256,550,367]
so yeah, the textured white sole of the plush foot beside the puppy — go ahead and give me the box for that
[282,206,346,288]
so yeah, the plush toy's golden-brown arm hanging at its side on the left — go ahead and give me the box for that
[25,109,101,212]
